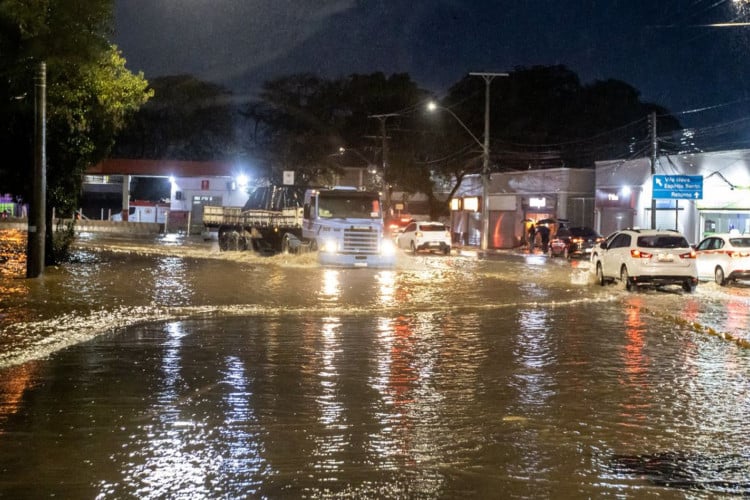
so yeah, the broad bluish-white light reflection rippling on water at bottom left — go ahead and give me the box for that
[98,322,272,498]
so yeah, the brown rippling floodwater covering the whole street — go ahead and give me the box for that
[0,231,750,498]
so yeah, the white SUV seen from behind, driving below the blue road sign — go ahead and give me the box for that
[591,229,698,292]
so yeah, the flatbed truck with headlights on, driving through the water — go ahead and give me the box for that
[203,186,396,268]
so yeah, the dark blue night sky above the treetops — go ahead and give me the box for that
[114,0,750,129]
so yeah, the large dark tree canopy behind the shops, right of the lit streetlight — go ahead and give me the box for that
[426,65,680,198]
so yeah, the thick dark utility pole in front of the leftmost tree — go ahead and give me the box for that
[26,62,47,278]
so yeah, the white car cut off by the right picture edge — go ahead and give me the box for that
[695,233,750,286]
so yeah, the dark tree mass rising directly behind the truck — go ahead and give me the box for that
[243,73,426,191]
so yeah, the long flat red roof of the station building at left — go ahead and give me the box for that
[86,158,238,177]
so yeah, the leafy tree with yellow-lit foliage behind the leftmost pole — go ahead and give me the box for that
[0,0,150,263]
